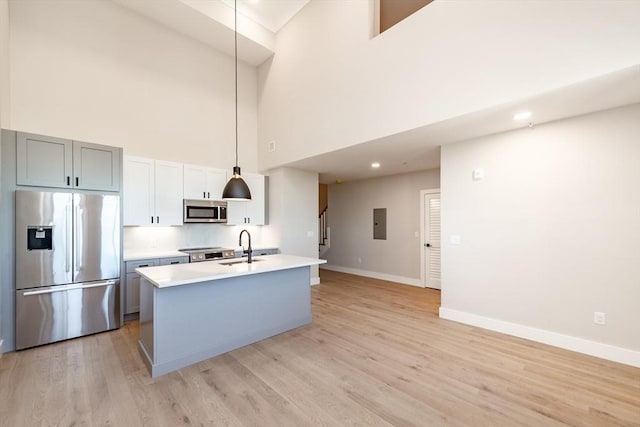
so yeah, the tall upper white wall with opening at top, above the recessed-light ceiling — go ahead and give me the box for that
[258,0,640,172]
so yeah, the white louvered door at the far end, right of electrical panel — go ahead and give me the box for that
[423,193,440,289]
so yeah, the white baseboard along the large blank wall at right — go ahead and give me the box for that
[440,307,640,368]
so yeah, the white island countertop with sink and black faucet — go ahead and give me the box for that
[136,254,327,288]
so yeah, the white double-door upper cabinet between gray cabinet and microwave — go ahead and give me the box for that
[123,156,183,226]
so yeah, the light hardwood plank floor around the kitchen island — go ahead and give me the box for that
[0,270,640,427]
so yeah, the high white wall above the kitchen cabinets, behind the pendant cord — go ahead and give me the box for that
[3,0,257,172]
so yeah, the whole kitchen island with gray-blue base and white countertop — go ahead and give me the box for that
[136,255,326,377]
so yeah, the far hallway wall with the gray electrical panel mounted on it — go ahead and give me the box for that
[324,169,440,285]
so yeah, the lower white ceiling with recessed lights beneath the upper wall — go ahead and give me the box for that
[287,65,640,184]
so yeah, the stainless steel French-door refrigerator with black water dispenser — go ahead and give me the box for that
[15,190,121,350]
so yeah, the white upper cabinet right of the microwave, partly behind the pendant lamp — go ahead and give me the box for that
[227,171,266,225]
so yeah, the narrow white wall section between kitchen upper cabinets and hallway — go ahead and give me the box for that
[263,168,320,283]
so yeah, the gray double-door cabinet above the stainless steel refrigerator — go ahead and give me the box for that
[16,132,122,191]
